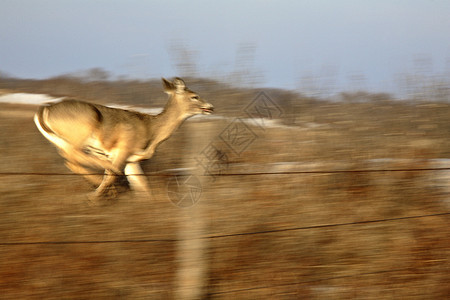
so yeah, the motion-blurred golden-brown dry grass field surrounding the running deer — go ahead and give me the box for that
[0,78,450,299]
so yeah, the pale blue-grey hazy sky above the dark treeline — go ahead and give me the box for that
[0,0,450,91]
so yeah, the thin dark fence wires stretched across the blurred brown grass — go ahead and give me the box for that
[0,167,450,296]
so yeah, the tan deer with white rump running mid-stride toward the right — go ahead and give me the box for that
[34,78,214,200]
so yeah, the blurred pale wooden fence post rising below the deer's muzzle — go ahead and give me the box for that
[175,121,215,300]
